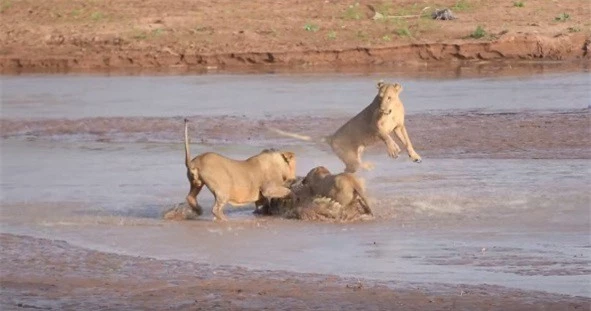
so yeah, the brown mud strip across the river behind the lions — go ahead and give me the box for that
[0,109,591,159]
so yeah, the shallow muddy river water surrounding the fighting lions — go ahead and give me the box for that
[0,73,591,297]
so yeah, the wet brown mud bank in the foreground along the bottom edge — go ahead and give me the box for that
[0,234,591,310]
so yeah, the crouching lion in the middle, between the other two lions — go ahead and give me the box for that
[302,166,373,215]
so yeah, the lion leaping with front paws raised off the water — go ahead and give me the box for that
[269,81,422,173]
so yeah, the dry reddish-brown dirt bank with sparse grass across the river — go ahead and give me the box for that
[0,0,591,73]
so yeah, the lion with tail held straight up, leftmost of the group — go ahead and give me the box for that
[185,119,296,221]
